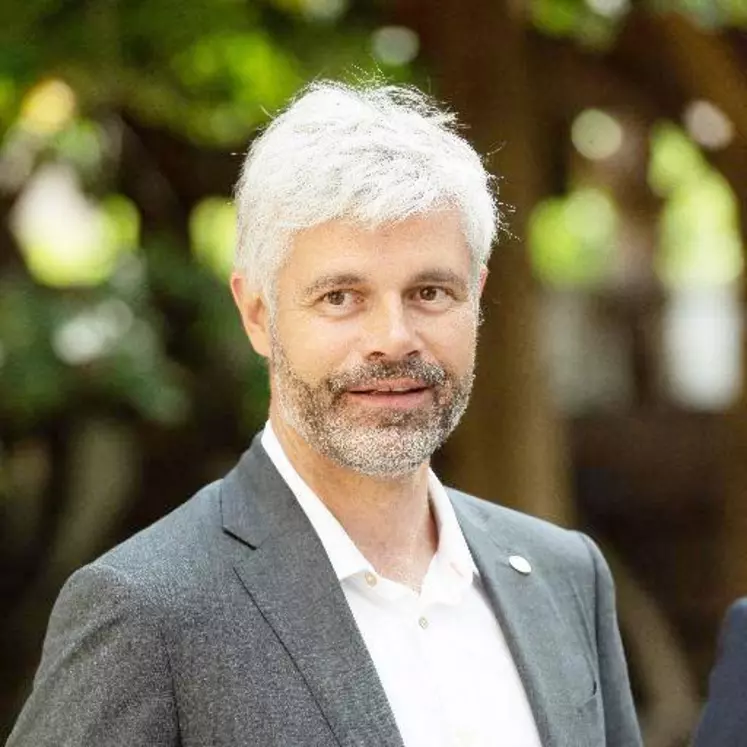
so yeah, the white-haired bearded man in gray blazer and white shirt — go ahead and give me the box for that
[10,84,640,747]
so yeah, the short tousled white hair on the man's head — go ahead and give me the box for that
[235,81,498,300]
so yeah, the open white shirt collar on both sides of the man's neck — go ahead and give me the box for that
[262,420,478,584]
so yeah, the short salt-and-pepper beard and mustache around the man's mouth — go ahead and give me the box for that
[271,338,474,478]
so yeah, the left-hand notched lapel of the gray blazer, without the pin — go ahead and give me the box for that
[221,439,403,747]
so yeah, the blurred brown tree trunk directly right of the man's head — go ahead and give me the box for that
[399,0,572,523]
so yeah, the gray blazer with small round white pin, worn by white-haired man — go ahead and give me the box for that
[7,439,640,747]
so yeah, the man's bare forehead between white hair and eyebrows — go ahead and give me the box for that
[280,211,470,283]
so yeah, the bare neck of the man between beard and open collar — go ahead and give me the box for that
[270,409,438,590]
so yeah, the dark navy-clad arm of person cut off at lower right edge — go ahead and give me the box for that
[694,597,747,747]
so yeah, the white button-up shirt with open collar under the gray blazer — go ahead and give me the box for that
[262,422,541,747]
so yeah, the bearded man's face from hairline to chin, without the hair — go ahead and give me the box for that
[253,212,477,477]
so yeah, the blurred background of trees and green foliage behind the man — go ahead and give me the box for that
[0,0,747,747]
